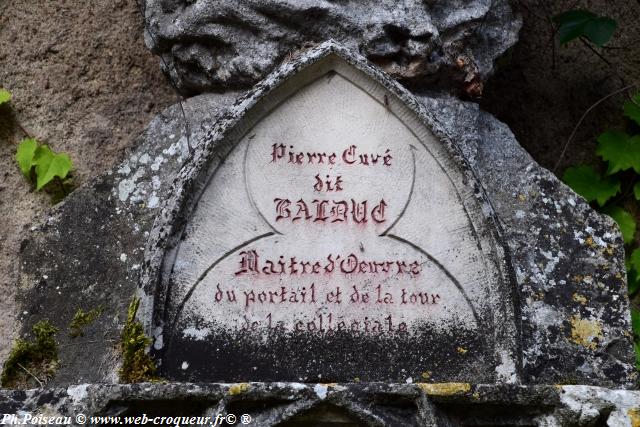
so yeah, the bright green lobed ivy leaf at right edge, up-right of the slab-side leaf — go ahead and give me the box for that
[596,130,640,175]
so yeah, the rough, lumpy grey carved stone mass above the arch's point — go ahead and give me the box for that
[145,0,521,96]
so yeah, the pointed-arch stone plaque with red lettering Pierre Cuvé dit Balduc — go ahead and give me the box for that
[143,43,519,382]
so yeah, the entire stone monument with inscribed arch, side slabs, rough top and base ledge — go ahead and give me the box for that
[0,0,640,426]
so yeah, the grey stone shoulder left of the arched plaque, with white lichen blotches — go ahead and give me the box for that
[18,93,235,384]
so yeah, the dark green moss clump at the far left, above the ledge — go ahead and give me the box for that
[0,320,58,389]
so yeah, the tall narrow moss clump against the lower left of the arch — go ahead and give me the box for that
[119,298,158,383]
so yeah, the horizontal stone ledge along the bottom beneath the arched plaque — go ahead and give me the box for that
[0,383,640,427]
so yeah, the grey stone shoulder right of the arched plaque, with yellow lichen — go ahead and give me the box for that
[422,98,638,385]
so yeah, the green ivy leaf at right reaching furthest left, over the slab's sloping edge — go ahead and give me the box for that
[562,166,620,206]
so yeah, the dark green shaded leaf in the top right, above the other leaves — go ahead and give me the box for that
[553,10,618,47]
